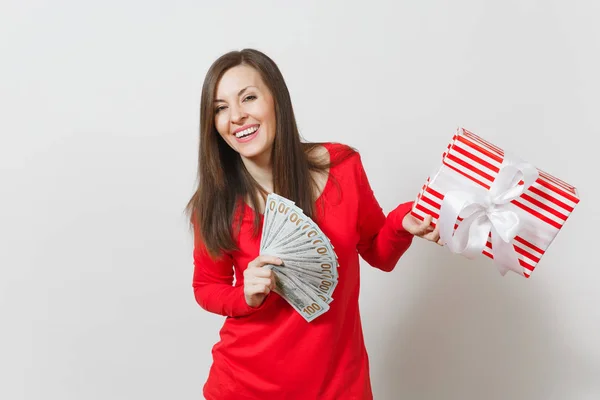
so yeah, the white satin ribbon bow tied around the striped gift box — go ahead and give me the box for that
[438,153,538,276]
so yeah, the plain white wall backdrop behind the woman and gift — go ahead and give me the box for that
[0,0,600,400]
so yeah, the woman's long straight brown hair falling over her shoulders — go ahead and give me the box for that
[186,49,352,256]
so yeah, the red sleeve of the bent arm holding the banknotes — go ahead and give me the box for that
[192,239,264,317]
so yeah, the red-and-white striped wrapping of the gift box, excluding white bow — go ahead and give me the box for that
[412,128,579,278]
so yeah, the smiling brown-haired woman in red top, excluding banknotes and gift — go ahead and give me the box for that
[188,49,439,400]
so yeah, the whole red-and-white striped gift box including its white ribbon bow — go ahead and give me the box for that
[411,128,579,278]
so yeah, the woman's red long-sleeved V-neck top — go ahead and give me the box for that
[193,144,413,400]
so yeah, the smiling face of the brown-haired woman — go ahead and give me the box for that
[214,65,275,162]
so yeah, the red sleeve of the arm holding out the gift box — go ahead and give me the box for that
[356,155,413,272]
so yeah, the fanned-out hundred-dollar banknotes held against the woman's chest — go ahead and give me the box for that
[260,194,338,322]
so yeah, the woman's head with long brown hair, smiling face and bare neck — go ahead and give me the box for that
[188,49,338,255]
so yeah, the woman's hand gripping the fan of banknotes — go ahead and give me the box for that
[244,255,282,308]
